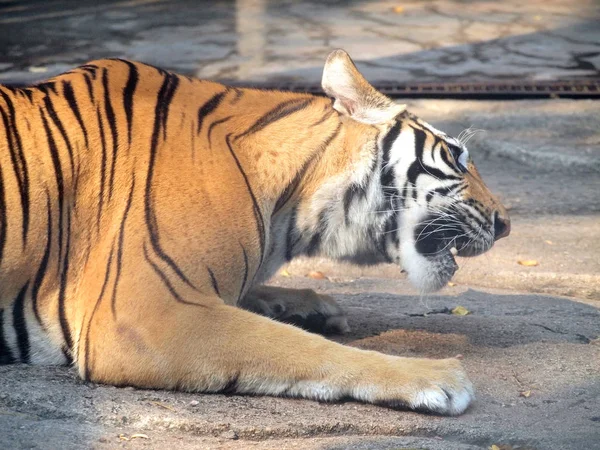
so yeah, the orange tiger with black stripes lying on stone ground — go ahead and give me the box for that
[0,50,510,415]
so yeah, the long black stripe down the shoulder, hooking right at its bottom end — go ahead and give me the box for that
[144,72,196,289]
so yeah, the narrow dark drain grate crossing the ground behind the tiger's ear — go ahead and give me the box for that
[234,79,600,100]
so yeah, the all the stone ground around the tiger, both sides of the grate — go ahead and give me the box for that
[0,0,600,450]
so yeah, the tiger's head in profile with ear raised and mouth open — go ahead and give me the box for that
[308,50,510,292]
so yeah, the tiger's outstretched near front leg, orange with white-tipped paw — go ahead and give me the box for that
[78,291,473,414]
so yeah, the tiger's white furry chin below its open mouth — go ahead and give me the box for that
[401,245,458,293]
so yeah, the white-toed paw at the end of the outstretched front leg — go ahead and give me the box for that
[360,358,475,416]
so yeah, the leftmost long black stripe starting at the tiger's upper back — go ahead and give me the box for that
[0,89,29,246]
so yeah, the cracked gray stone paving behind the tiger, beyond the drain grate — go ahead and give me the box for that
[0,0,600,82]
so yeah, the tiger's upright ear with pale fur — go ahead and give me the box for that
[321,49,406,124]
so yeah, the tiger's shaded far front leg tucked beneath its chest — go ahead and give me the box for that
[239,286,350,334]
